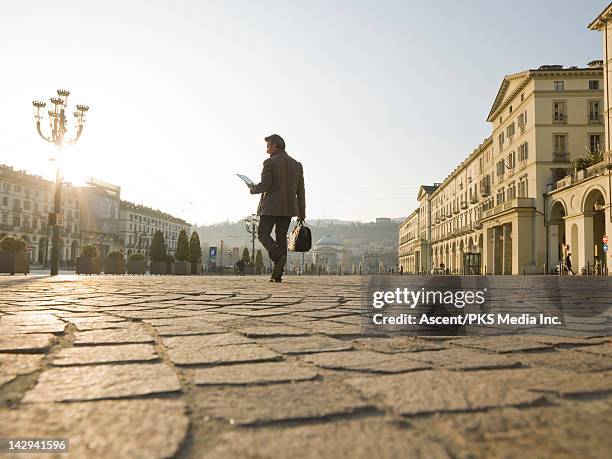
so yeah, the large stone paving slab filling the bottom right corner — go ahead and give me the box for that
[414,400,612,459]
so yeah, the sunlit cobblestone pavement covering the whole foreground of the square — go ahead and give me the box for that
[0,276,612,458]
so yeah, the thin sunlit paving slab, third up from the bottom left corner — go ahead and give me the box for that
[52,344,158,366]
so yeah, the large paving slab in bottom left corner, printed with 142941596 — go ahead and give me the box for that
[0,399,189,459]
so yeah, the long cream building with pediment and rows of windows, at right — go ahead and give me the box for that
[400,61,609,274]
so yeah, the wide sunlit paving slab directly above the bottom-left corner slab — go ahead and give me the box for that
[23,363,181,403]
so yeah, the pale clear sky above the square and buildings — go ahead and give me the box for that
[0,0,607,224]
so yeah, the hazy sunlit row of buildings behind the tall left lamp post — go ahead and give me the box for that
[0,164,191,268]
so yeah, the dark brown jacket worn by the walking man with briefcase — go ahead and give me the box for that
[251,151,306,219]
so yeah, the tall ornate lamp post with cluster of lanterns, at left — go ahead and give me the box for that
[32,89,89,276]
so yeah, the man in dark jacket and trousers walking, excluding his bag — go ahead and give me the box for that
[249,134,306,282]
